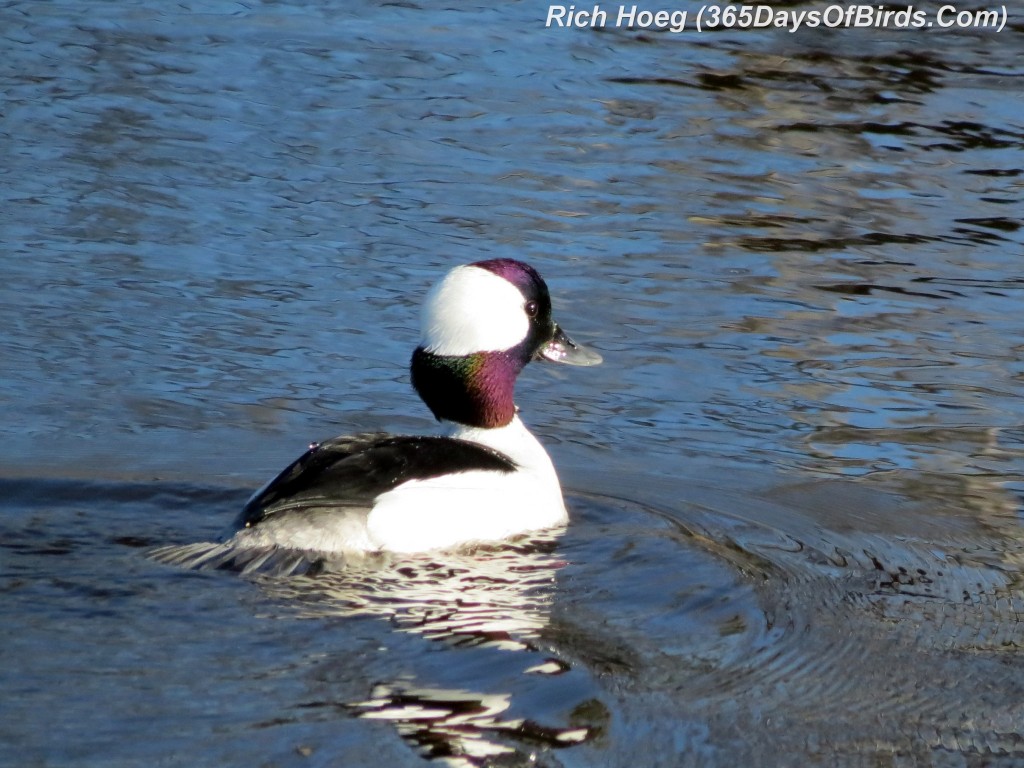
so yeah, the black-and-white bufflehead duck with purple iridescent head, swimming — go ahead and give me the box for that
[161,259,601,564]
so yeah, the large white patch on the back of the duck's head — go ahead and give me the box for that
[422,265,529,357]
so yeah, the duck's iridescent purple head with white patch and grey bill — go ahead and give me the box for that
[412,259,601,428]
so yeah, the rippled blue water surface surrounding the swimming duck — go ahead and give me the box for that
[6,0,1024,766]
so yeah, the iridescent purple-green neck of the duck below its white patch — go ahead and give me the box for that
[412,347,523,429]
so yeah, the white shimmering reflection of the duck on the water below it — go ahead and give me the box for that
[247,531,597,766]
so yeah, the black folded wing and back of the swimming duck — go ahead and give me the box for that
[236,432,516,528]
